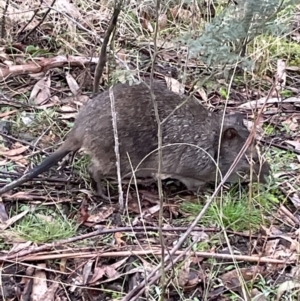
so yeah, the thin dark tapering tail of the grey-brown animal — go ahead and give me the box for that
[0,149,70,195]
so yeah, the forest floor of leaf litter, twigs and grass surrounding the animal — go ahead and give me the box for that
[0,0,300,301]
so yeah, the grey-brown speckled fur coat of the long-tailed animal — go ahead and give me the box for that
[0,82,269,194]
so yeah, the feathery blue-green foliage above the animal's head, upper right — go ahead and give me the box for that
[179,0,295,69]
